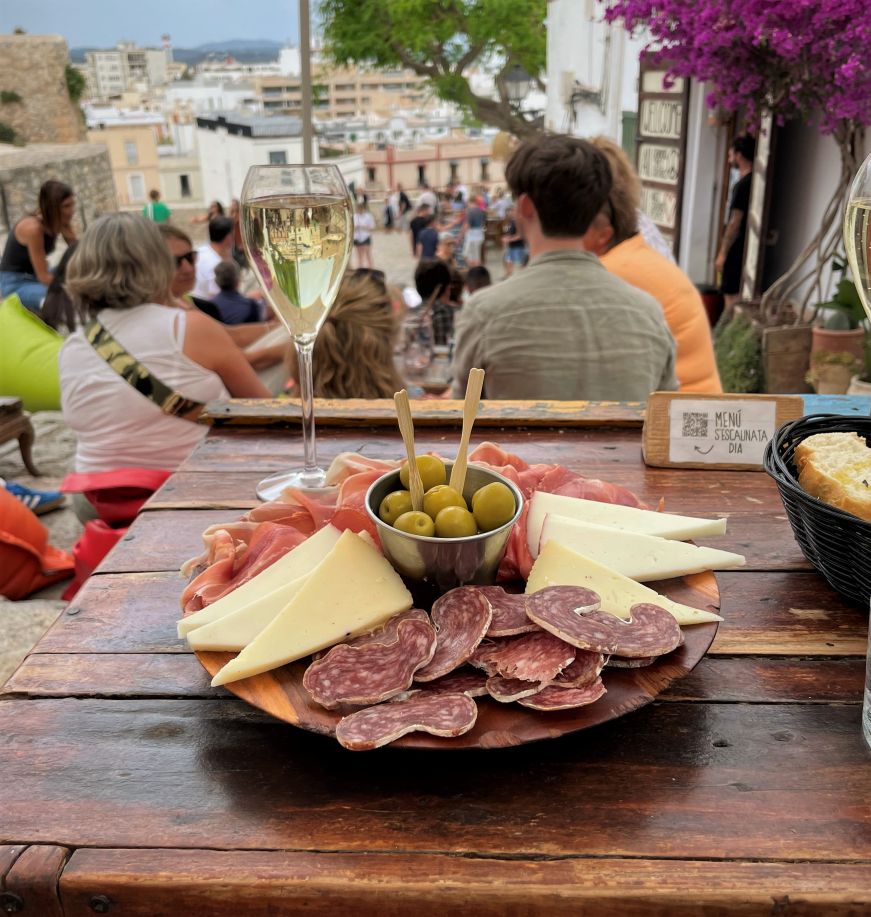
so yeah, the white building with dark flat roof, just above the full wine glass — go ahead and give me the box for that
[197,114,365,202]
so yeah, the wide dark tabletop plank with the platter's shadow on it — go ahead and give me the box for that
[0,698,871,861]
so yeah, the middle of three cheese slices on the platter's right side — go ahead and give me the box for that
[540,513,744,583]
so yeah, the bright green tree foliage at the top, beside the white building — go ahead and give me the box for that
[318,0,547,134]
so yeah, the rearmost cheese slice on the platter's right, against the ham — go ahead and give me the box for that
[526,491,726,557]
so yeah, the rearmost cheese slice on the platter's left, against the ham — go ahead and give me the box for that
[178,525,342,637]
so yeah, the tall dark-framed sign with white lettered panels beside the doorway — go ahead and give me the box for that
[636,58,689,254]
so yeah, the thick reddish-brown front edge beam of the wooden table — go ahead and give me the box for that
[60,849,871,917]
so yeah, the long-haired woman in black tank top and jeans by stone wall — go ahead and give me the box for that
[0,181,76,312]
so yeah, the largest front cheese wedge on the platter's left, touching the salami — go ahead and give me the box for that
[212,531,412,685]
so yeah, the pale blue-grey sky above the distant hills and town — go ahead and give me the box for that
[0,0,304,48]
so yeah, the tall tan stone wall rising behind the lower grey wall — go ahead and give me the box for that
[0,35,85,143]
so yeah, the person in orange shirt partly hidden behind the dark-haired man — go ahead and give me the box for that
[584,137,723,394]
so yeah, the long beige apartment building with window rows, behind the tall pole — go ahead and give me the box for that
[254,64,437,120]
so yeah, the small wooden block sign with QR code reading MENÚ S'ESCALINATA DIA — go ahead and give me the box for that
[641,392,804,471]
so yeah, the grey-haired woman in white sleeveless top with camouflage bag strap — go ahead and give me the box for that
[59,213,269,472]
